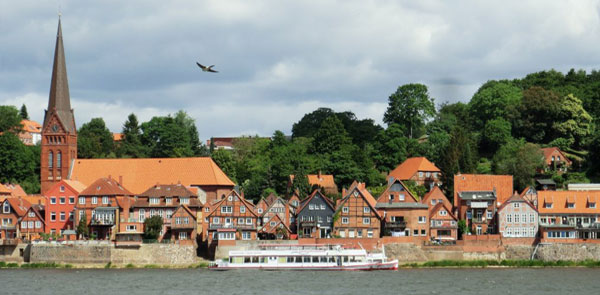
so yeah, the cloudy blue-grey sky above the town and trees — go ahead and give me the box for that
[0,0,600,139]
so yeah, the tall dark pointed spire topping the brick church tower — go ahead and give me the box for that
[44,15,76,133]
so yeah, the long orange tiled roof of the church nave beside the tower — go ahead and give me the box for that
[69,157,235,194]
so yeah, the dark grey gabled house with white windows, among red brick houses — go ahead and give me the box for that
[296,189,335,238]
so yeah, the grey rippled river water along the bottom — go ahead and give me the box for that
[0,268,600,295]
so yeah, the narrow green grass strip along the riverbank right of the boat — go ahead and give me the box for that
[402,260,600,268]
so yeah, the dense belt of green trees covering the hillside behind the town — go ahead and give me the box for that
[0,70,600,199]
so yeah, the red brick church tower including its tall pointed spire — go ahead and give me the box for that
[40,17,77,194]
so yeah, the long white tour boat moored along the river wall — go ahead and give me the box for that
[210,244,398,270]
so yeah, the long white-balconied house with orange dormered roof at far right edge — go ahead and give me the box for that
[538,191,600,242]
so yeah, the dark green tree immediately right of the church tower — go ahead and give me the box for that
[77,118,114,159]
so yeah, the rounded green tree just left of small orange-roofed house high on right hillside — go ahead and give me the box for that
[493,139,543,191]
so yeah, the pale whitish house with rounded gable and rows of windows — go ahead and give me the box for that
[498,192,538,238]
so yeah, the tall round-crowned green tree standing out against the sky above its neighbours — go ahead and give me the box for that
[383,84,435,138]
